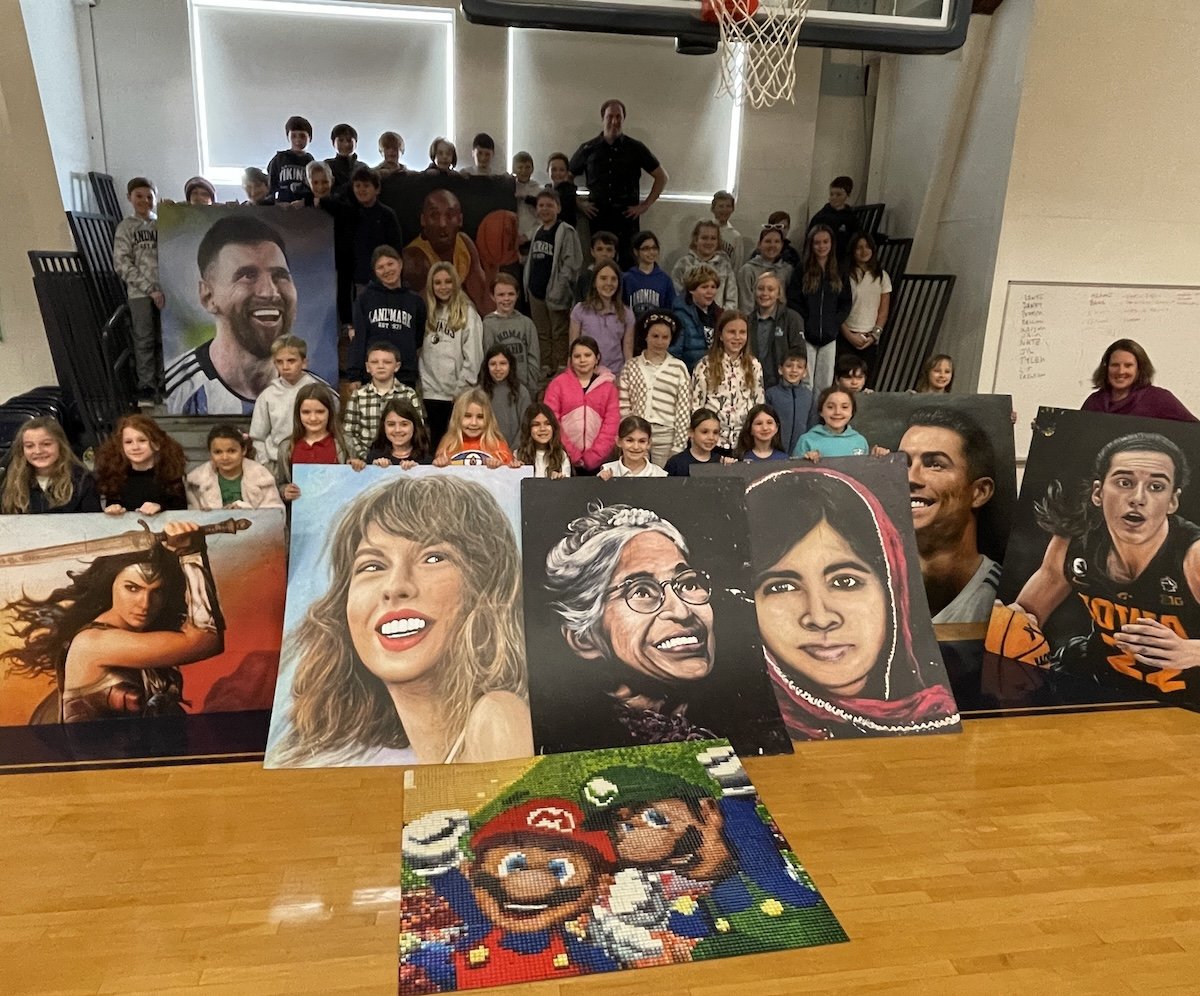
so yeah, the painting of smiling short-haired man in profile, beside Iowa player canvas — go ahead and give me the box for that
[854,394,1016,624]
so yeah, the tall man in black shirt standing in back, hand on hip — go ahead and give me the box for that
[569,98,667,270]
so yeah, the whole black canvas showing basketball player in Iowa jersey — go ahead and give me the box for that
[985,409,1200,708]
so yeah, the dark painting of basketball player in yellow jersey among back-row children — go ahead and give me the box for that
[379,170,516,314]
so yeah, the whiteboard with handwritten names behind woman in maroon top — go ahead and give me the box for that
[980,281,1200,458]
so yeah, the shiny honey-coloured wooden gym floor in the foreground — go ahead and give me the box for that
[0,709,1200,996]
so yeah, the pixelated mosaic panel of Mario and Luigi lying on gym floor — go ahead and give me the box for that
[400,742,847,996]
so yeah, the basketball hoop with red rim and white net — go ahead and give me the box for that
[700,0,809,108]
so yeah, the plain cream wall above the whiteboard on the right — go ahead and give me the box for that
[982,0,1200,400]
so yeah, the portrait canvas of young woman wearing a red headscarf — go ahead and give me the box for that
[745,457,959,740]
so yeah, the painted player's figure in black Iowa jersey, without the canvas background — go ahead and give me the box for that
[990,432,1200,702]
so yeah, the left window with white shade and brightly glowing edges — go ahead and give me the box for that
[191,0,455,185]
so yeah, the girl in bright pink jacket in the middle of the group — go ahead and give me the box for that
[546,336,620,475]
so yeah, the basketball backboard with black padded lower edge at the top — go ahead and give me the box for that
[462,0,971,54]
